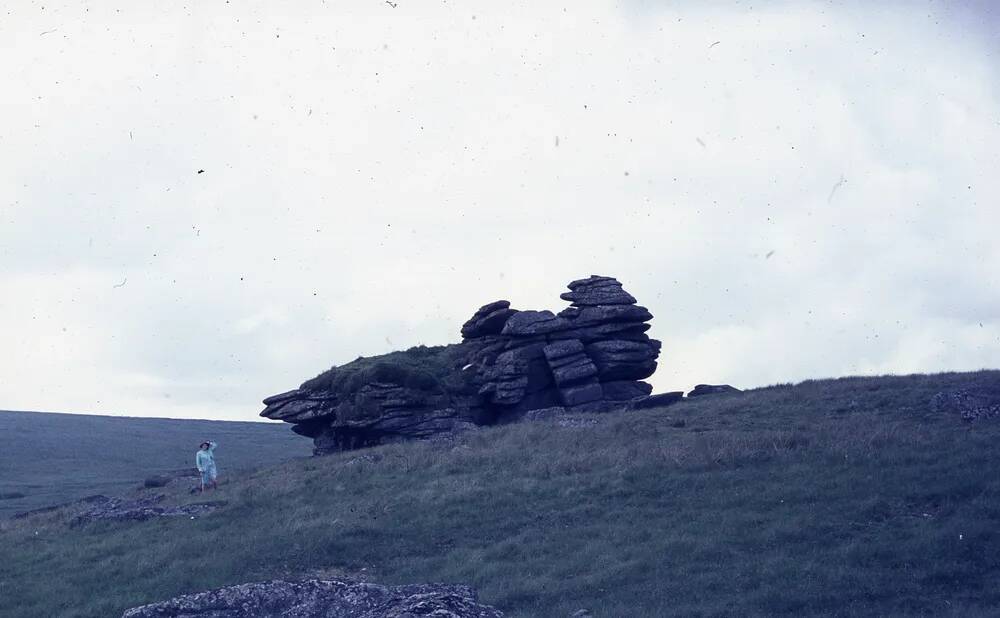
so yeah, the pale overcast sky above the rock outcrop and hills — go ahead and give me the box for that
[0,0,1000,420]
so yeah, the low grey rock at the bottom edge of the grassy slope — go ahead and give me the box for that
[122,579,503,618]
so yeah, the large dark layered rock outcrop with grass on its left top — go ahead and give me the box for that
[261,275,660,454]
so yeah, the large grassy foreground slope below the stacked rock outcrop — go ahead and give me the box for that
[0,372,1000,618]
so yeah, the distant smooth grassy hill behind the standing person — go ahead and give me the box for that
[0,411,311,516]
